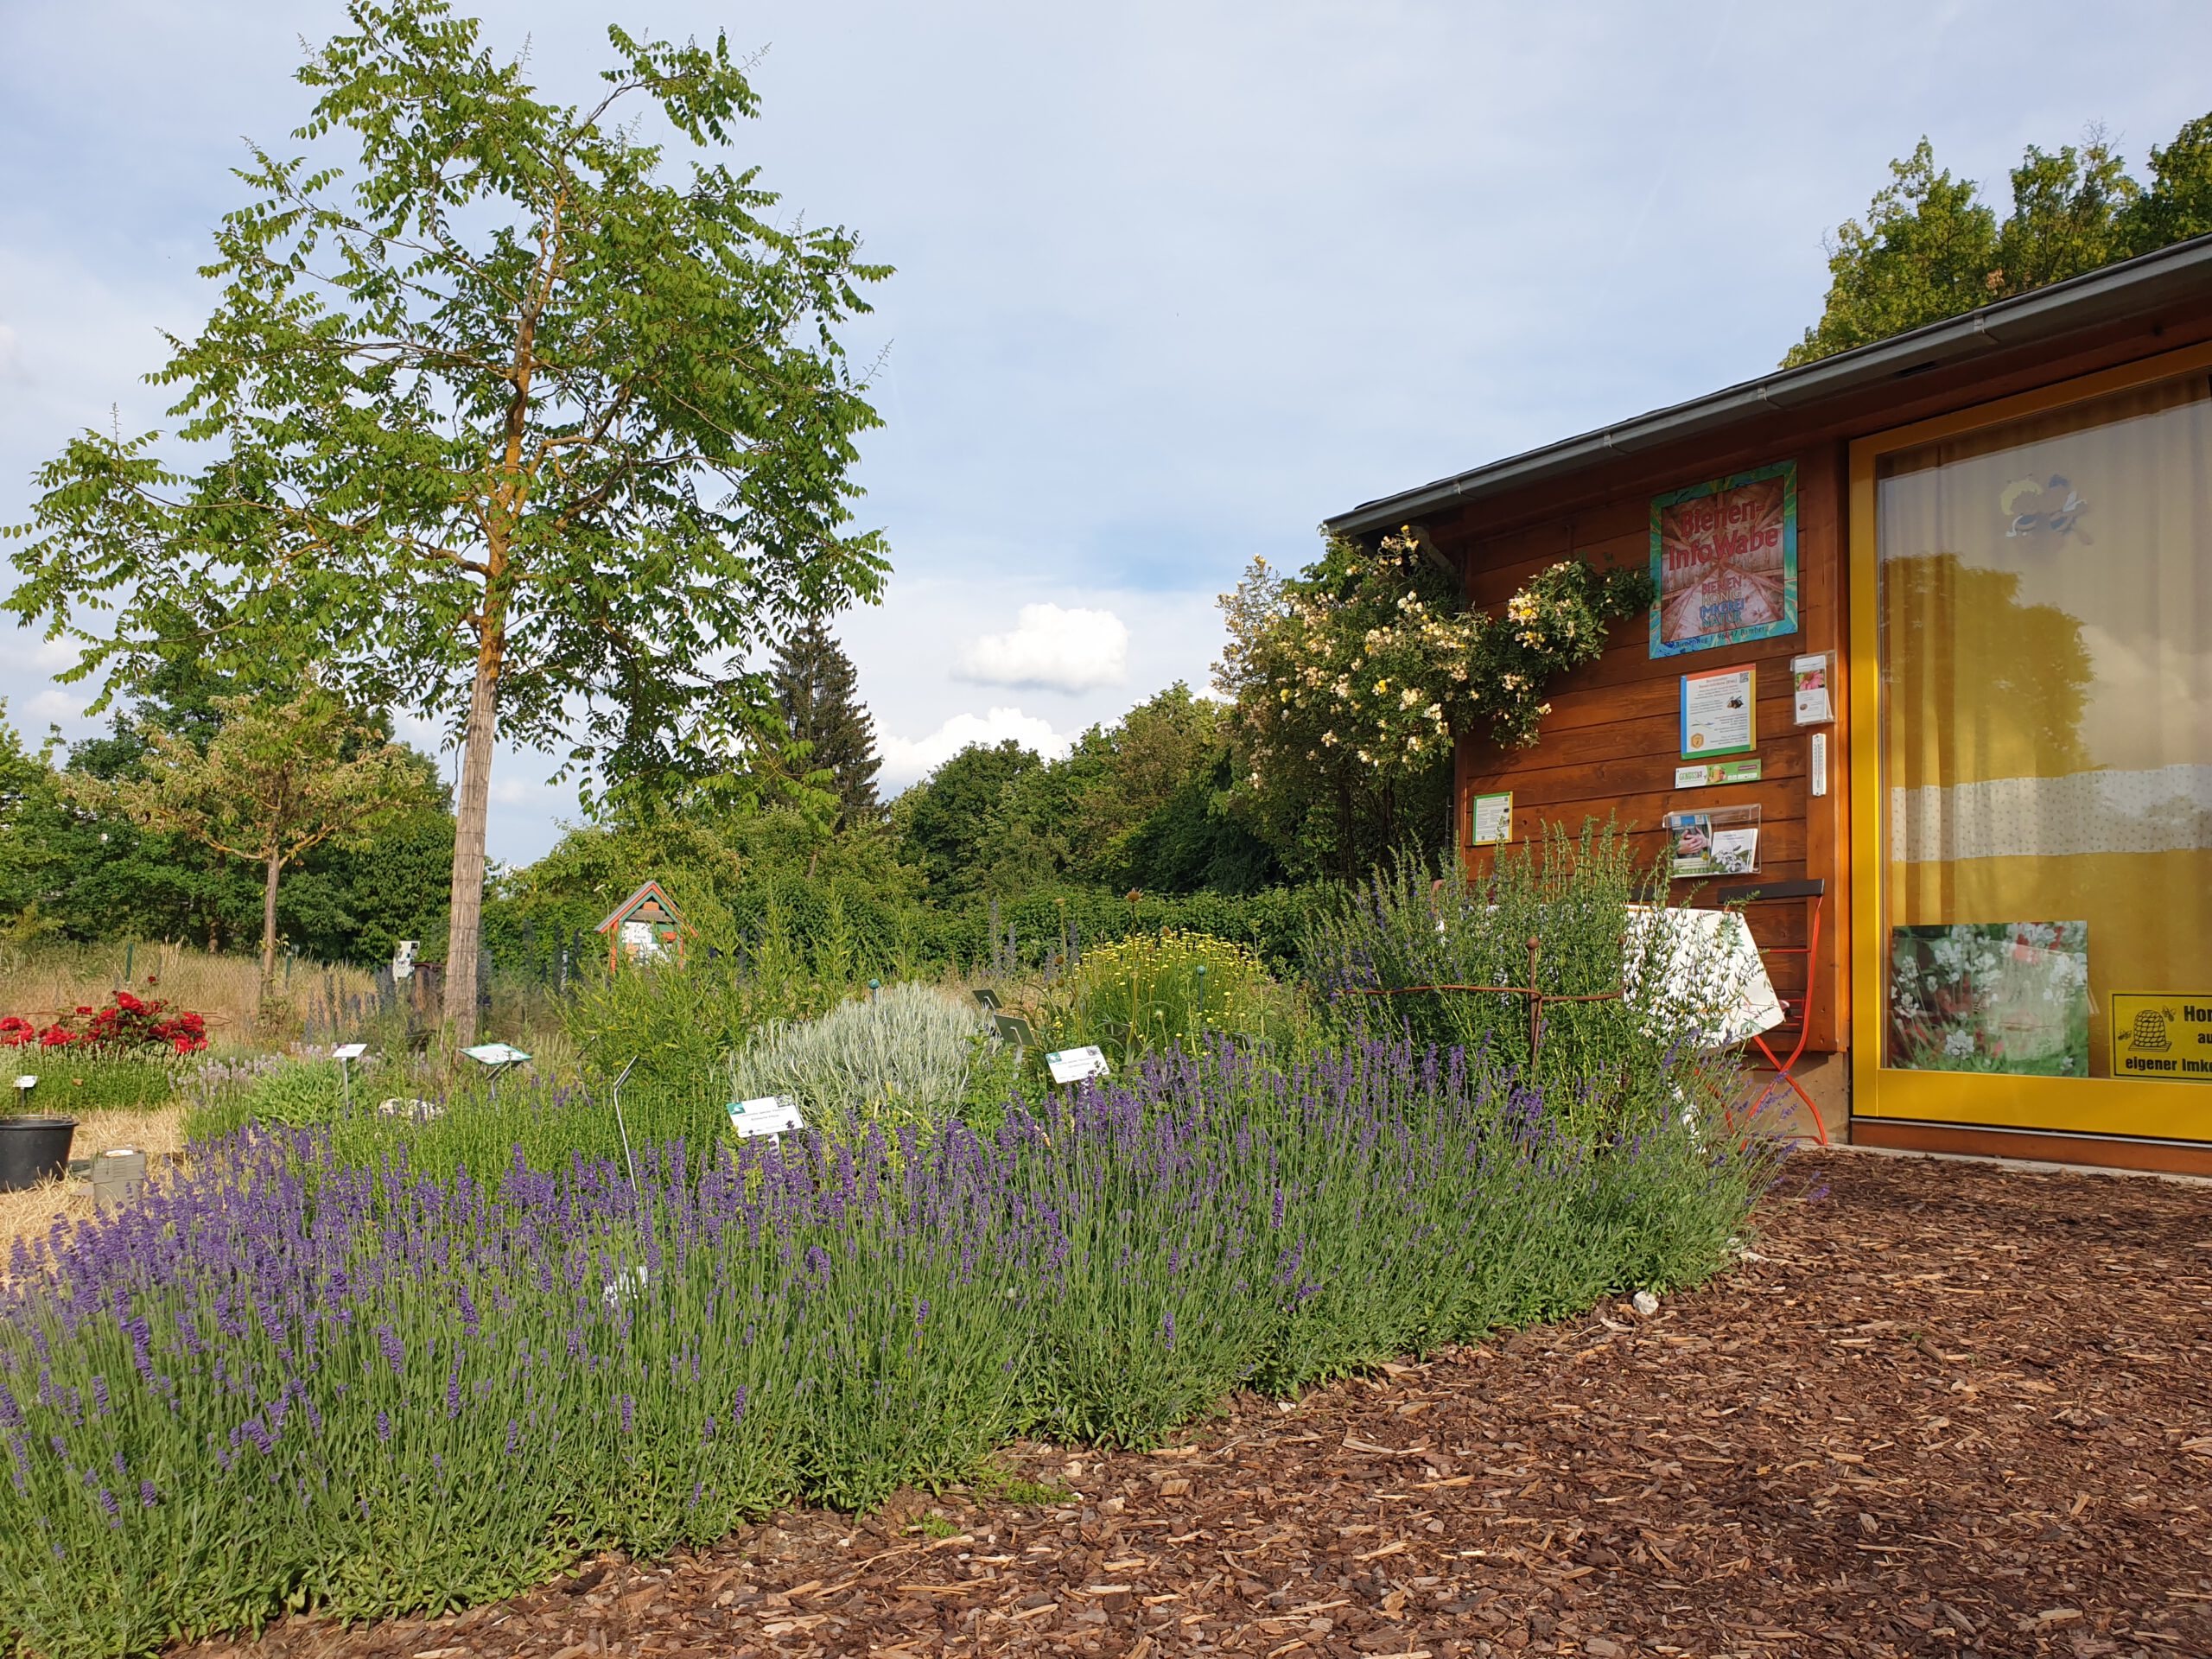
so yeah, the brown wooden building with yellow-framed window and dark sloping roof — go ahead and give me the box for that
[1327,237,2212,1173]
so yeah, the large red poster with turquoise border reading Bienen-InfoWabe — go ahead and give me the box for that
[1652,460,1796,657]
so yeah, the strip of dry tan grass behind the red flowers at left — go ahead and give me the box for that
[0,944,376,1042]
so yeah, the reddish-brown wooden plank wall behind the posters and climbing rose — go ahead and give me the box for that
[1431,445,1849,1051]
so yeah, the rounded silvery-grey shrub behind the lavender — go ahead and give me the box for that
[728,984,1000,1123]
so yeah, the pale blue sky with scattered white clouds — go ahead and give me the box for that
[0,0,2212,865]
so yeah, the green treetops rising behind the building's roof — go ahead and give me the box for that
[1783,115,2212,367]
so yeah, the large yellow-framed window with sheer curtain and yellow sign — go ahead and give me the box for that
[1858,372,2212,1137]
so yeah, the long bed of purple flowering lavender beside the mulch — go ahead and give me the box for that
[0,1042,1767,1659]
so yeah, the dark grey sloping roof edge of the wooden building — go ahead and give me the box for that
[1320,234,2212,536]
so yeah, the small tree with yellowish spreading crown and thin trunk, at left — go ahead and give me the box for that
[73,686,427,1002]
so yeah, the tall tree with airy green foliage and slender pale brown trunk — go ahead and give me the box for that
[7,0,887,1031]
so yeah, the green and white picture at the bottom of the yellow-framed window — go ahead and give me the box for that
[1883,923,2090,1077]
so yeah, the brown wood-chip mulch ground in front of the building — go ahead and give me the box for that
[194,1153,2212,1659]
